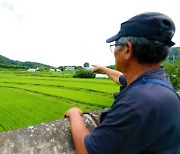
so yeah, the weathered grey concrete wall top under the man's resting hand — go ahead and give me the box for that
[0,111,102,154]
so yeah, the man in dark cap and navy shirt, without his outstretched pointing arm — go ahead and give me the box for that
[65,12,180,154]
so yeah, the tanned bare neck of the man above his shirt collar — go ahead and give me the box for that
[124,63,161,85]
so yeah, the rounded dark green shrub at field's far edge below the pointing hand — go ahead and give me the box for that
[73,69,95,78]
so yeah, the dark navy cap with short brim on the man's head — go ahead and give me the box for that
[106,12,175,46]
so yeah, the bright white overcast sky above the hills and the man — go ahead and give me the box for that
[0,0,180,66]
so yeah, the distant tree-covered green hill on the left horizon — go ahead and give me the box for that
[0,55,52,69]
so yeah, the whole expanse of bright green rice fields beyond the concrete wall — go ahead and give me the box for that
[0,70,119,132]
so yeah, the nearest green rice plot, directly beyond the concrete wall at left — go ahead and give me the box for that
[0,87,81,131]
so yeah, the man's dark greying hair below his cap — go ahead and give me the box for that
[115,36,170,64]
